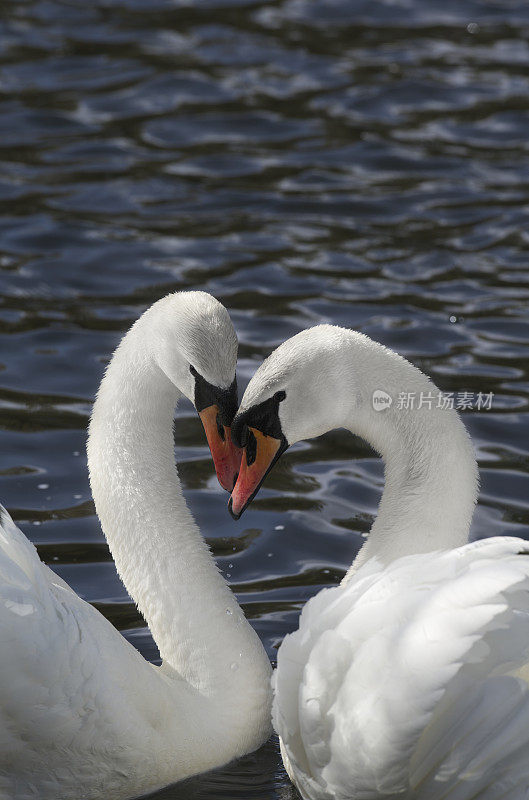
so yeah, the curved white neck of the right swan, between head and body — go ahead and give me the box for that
[322,334,478,569]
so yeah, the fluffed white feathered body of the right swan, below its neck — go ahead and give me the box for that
[273,538,529,800]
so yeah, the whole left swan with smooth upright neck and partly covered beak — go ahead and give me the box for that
[0,292,271,800]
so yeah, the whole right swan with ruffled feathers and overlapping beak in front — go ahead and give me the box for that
[229,325,529,800]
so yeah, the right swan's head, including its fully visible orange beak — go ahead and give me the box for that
[228,325,350,519]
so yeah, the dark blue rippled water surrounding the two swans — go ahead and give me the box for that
[0,0,529,800]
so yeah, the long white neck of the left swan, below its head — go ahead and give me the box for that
[88,324,270,709]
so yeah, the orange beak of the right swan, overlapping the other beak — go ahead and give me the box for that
[228,428,286,519]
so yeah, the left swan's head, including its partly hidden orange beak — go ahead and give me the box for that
[147,292,242,492]
